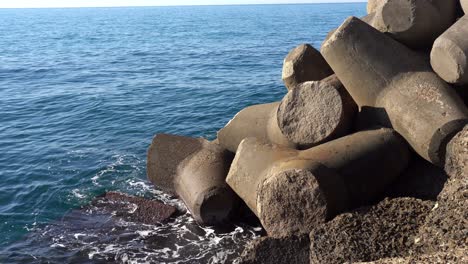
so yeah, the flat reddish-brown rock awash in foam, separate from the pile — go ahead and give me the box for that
[93,192,177,225]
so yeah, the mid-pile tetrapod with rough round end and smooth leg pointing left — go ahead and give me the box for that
[218,75,357,152]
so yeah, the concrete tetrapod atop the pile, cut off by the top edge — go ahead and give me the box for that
[369,0,458,48]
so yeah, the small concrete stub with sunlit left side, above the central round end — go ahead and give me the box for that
[282,44,333,90]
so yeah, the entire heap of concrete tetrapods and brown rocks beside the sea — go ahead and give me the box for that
[144,0,468,263]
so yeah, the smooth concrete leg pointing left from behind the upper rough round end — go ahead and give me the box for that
[218,102,296,152]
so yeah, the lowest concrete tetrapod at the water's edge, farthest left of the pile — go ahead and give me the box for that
[147,134,239,224]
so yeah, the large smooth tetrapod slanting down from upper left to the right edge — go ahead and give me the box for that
[322,17,468,166]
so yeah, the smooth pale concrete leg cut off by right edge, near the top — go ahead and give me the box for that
[431,15,468,85]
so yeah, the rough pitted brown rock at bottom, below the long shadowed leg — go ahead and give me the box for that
[310,198,434,264]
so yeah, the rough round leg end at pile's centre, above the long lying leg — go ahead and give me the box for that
[277,75,357,149]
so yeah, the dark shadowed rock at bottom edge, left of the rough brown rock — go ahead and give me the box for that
[239,236,310,264]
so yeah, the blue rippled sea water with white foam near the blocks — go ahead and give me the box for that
[0,3,365,263]
